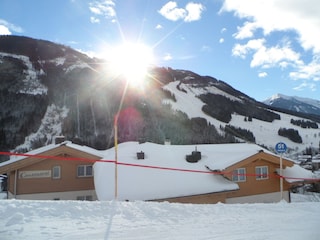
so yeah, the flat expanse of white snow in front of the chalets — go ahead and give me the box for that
[0,194,320,240]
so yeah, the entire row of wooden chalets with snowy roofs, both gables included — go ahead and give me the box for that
[0,141,314,203]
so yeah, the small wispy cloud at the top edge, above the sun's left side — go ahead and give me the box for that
[89,0,116,23]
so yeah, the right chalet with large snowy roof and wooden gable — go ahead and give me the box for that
[94,142,314,203]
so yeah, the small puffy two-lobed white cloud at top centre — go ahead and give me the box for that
[159,1,205,22]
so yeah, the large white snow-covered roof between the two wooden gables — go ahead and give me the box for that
[94,142,268,200]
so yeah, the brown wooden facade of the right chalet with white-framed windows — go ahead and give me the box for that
[157,151,293,204]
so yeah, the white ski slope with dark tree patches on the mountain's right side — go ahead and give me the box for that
[164,81,320,157]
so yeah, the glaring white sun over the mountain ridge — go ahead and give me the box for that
[109,43,154,87]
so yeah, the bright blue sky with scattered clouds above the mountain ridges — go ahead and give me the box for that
[0,0,320,101]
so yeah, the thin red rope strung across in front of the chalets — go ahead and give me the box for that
[0,152,320,182]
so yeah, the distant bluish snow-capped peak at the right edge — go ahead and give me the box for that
[263,94,320,116]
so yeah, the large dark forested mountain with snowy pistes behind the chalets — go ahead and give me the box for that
[0,36,320,158]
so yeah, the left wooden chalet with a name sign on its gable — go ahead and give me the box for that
[0,141,102,200]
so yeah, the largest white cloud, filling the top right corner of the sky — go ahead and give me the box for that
[220,0,320,53]
